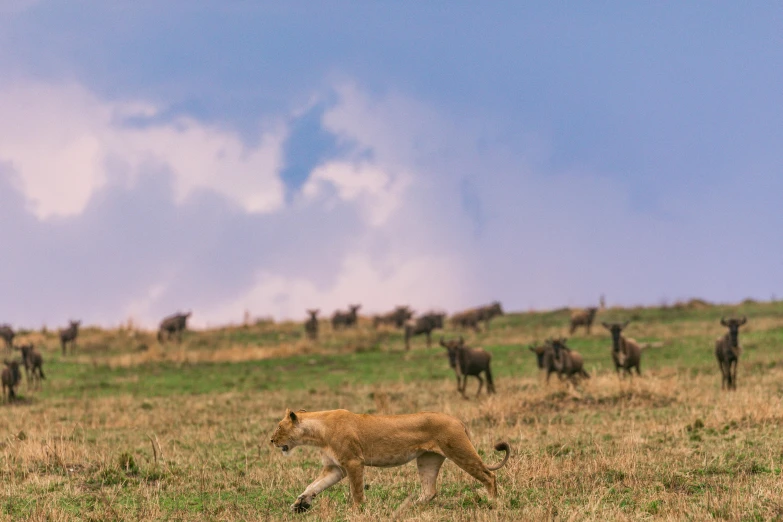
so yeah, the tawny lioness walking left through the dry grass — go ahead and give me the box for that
[271,409,511,513]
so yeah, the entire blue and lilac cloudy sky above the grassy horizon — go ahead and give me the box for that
[0,0,783,327]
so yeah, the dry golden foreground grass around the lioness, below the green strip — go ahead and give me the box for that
[0,370,783,520]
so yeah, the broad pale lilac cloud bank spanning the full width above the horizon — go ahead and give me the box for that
[0,78,783,326]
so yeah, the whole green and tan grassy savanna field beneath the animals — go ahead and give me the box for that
[0,302,783,520]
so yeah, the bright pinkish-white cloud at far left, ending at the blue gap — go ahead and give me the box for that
[0,83,286,219]
